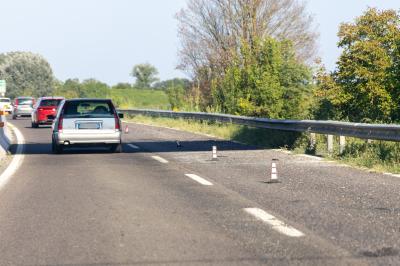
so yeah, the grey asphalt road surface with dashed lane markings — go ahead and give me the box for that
[0,120,400,265]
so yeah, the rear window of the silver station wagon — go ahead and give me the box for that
[64,100,114,118]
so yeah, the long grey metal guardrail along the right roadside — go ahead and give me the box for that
[119,109,400,141]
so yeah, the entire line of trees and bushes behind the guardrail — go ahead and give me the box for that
[0,0,400,123]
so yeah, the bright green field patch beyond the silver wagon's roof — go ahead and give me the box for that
[110,89,169,110]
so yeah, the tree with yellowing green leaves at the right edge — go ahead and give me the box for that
[321,8,400,122]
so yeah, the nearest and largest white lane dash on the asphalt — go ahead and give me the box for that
[244,208,305,237]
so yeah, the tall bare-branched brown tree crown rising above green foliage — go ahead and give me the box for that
[177,0,318,103]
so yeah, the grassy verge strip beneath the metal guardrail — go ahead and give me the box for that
[128,116,400,174]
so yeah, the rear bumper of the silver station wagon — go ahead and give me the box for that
[55,131,122,145]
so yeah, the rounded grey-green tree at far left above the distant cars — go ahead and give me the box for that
[0,52,54,98]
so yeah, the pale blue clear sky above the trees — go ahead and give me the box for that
[0,0,400,85]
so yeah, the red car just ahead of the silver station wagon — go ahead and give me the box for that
[32,97,64,128]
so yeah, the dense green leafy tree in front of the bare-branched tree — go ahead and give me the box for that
[212,38,312,118]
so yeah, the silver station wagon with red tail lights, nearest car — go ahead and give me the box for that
[49,99,123,153]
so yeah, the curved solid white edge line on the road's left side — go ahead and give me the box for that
[0,122,25,189]
